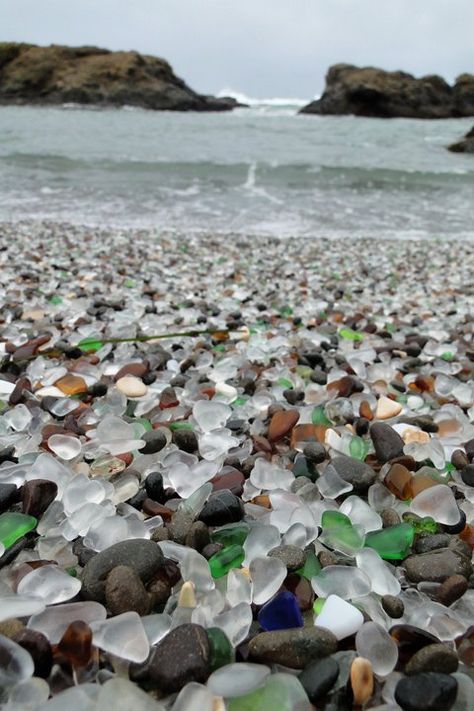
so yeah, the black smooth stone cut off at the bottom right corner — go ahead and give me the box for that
[395,672,458,711]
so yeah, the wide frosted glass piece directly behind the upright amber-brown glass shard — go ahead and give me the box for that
[27,601,107,644]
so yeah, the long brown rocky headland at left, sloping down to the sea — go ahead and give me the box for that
[0,42,238,111]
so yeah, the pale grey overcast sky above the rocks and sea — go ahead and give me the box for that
[0,0,474,98]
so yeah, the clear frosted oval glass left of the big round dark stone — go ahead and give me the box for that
[17,565,81,605]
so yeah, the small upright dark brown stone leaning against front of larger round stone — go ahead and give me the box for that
[105,565,150,616]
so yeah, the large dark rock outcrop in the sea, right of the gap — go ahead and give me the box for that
[300,64,474,118]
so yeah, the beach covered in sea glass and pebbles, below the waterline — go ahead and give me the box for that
[0,220,474,711]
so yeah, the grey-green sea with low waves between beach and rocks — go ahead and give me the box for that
[0,99,474,239]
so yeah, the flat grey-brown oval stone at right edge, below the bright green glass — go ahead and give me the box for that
[403,548,472,583]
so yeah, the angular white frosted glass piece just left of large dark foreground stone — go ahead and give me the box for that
[91,612,150,663]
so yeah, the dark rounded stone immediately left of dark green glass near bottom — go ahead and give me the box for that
[147,623,211,693]
